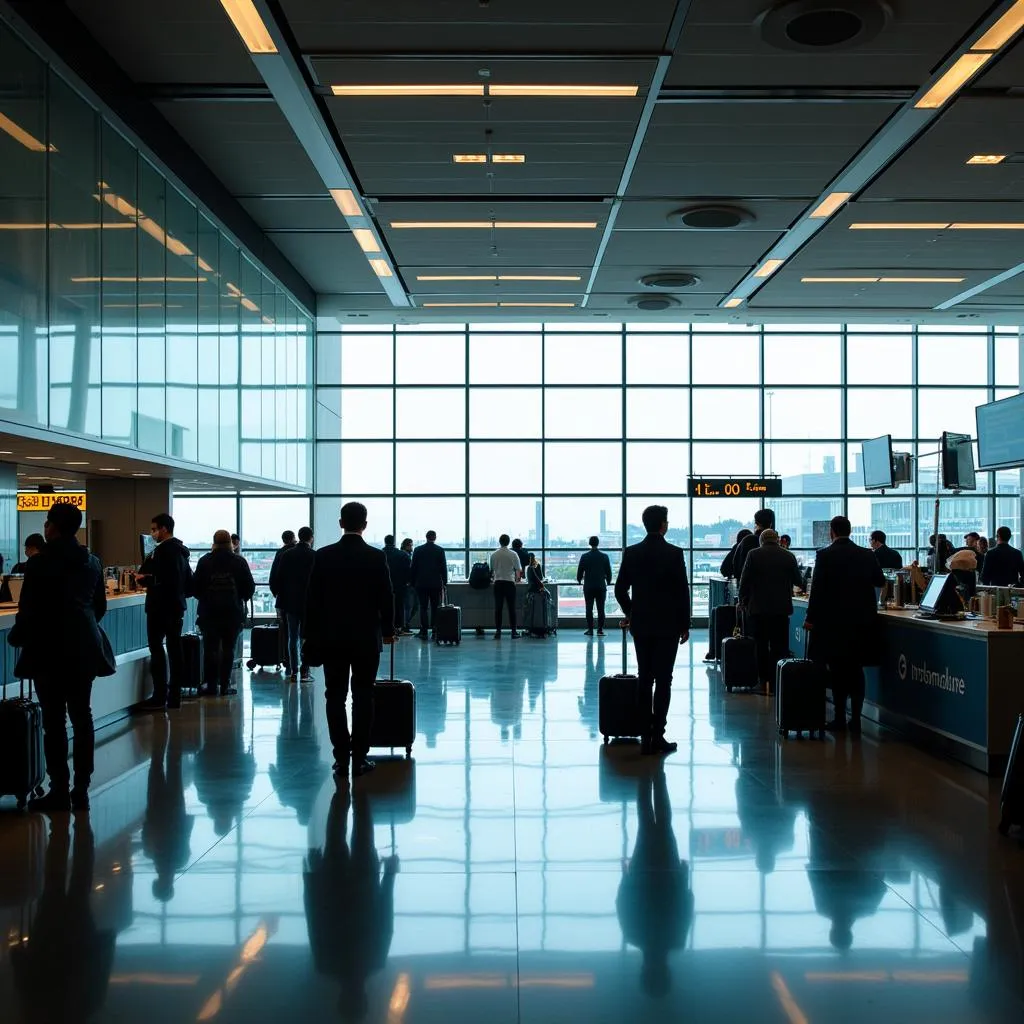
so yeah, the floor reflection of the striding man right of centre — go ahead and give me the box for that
[615,762,693,997]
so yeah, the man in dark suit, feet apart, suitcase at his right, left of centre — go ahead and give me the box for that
[302,502,397,775]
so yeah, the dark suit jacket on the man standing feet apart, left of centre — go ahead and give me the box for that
[302,534,394,665]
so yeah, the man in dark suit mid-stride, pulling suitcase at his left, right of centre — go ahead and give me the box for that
[615,505,690,754]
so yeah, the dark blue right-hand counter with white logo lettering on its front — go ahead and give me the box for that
[790,598,1024,775]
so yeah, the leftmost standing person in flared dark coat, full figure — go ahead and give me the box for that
[7,502,117,812]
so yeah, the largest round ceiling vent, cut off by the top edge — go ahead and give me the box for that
[755,0,892,51]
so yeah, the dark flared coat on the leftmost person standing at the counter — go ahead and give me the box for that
[7,537,116,679]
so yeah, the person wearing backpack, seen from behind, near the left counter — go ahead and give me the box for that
[193,529,256,697]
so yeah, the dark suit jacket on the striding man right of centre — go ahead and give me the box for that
[615,534,690,637]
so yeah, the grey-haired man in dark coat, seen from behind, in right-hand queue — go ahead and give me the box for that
[739,529,804,689]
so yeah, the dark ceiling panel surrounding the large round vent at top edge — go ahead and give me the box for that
[667,0,991,88]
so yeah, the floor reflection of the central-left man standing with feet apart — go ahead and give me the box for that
[303,785,398,1020]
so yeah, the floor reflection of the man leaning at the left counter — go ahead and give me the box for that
[142,716,196,903]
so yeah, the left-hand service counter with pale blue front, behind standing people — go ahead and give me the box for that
[0,594,196,726]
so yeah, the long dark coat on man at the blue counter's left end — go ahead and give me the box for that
[807,538,885,666]
